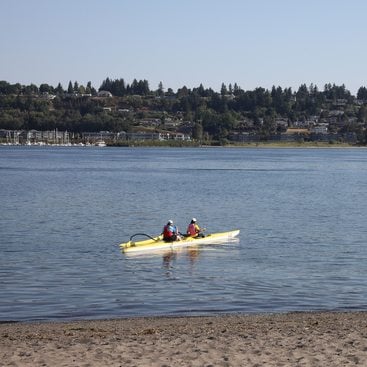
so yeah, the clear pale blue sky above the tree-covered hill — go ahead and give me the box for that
[0,0,367,94]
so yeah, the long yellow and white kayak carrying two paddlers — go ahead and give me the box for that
[119,229,240,252]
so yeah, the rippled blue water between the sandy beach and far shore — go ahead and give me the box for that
[0,147,367,321]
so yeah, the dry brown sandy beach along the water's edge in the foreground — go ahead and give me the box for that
[0,312,367,367]
